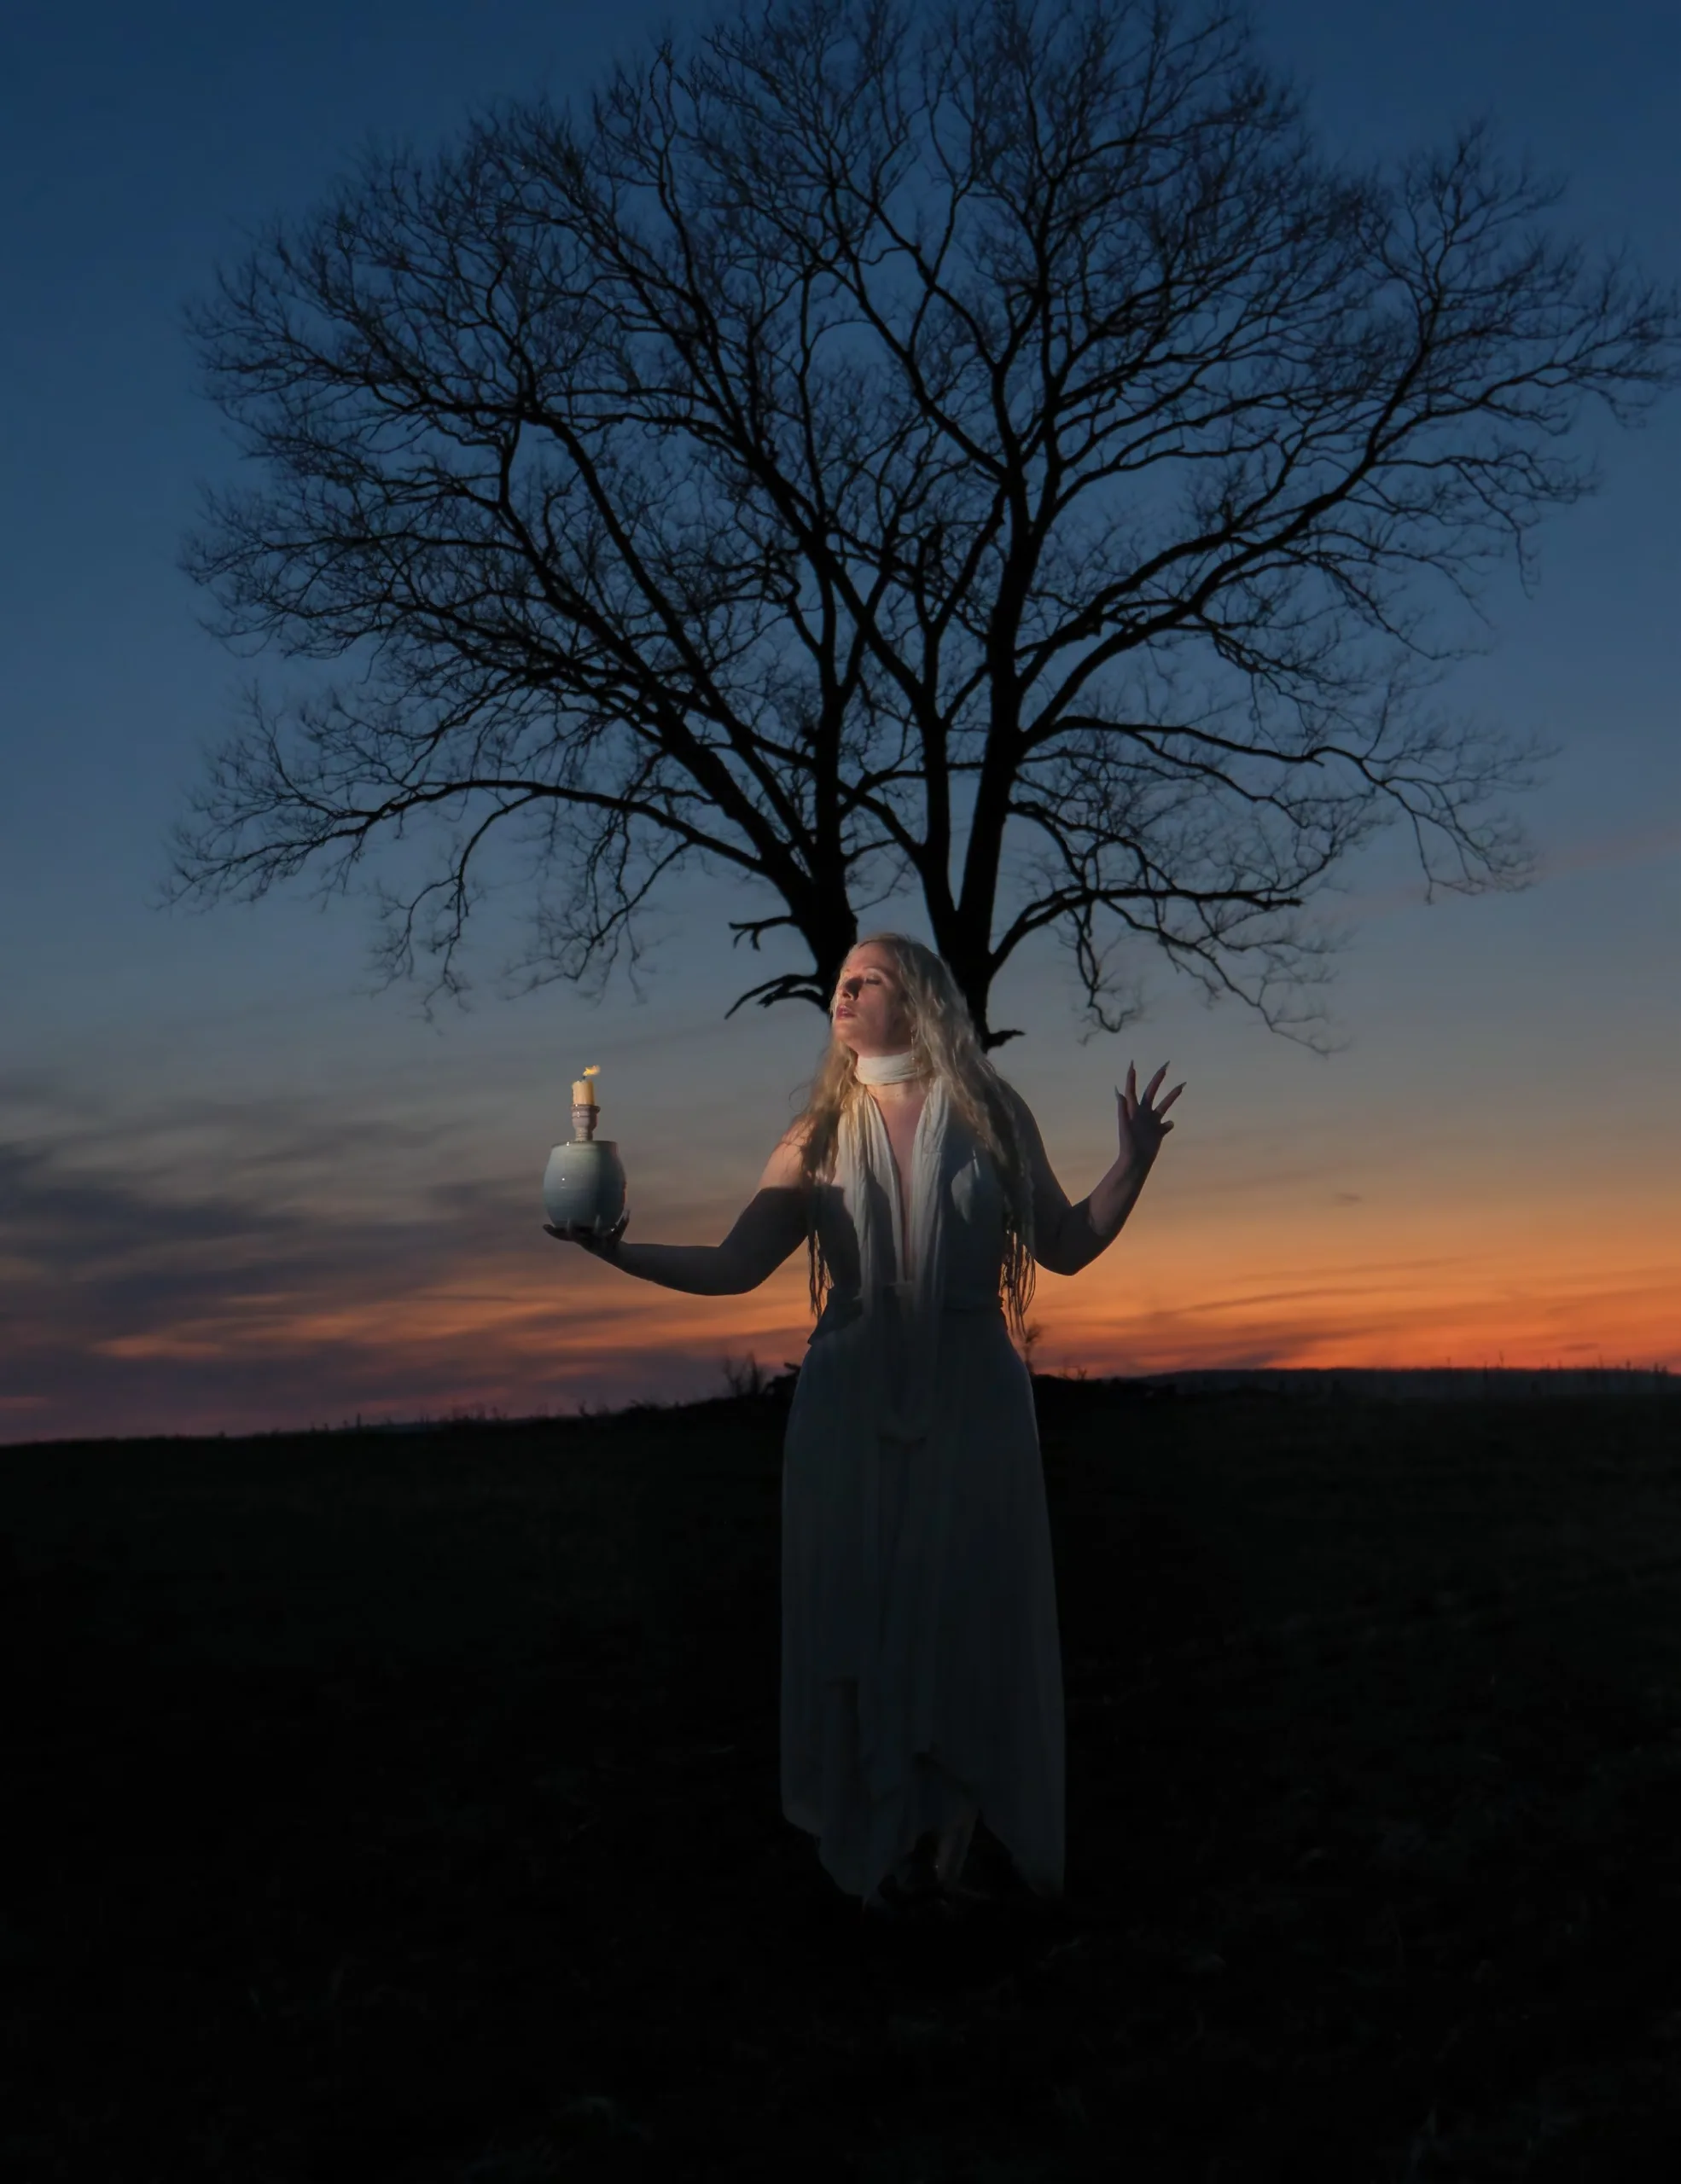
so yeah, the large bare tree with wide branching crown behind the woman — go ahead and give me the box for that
[164,0,1677,1046]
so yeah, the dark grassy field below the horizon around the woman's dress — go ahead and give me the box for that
[0,1382,1681,2184]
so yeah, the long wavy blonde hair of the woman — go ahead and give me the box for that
[790,932,1032,1341]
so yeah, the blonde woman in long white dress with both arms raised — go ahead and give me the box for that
[550,932,1184,1911]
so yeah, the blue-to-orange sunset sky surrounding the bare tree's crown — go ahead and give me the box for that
[0,0,1681,1442]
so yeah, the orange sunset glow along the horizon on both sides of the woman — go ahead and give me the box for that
[13,1212,1681,1439]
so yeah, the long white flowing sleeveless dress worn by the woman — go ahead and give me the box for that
[782,1083,1063,1898]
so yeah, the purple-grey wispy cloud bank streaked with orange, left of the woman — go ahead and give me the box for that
[0,1072,804,1439]
